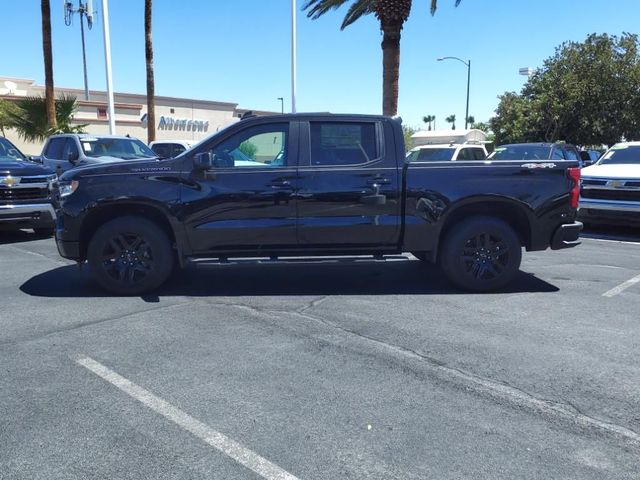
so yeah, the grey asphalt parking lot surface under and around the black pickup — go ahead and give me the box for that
[0,230,640,480]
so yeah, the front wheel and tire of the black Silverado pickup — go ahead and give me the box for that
[87,216,175,295]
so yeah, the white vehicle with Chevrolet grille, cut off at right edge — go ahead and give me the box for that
[578,142,640,226]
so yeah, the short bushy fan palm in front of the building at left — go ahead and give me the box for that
[8,95,87,142]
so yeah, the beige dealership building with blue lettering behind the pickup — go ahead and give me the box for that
[0,76,275,155]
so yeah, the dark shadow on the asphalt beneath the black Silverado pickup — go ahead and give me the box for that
[20,261,559,302]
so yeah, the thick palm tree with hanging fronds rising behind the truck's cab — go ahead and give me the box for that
[302,0,461,116]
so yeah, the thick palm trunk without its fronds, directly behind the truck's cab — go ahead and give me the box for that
[380,20,402,117]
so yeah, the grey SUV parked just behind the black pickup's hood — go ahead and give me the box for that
[36,133,157,173]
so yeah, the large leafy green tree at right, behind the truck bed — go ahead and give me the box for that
[489,33,640,146]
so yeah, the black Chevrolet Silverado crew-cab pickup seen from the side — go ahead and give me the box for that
[56,114,582,294]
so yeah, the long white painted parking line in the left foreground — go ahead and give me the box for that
[74,356,298,480]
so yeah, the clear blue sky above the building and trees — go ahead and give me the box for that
[0,0,640,128]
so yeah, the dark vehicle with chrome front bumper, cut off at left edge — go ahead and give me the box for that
[0,137,58,235]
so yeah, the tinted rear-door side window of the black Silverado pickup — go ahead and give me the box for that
[311,122,378,165]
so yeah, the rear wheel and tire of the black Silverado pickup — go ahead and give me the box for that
[439,216,522,292]
